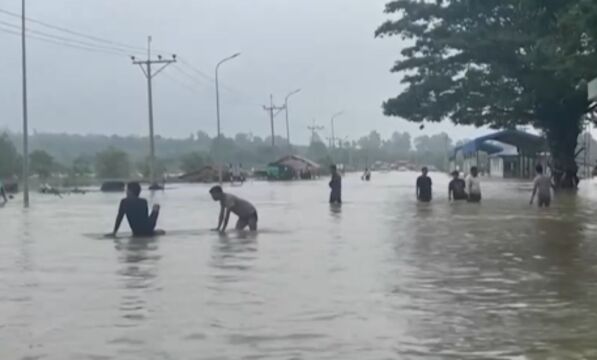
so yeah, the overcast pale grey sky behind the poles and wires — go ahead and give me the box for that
[0,0,487,143]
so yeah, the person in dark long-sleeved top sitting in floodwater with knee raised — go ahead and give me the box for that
[111,182,161,236]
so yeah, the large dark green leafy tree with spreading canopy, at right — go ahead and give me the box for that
[376,0,597,187]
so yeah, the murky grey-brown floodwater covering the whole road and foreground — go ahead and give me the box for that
[0,173,597,360]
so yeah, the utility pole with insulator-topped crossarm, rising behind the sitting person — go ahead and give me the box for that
[131,36,176,190]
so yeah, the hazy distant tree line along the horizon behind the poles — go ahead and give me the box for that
[10,131,597,183]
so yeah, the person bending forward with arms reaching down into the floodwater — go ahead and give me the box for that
[209,186,259,233]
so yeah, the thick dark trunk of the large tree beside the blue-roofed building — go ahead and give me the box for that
[541,107,582,189]
